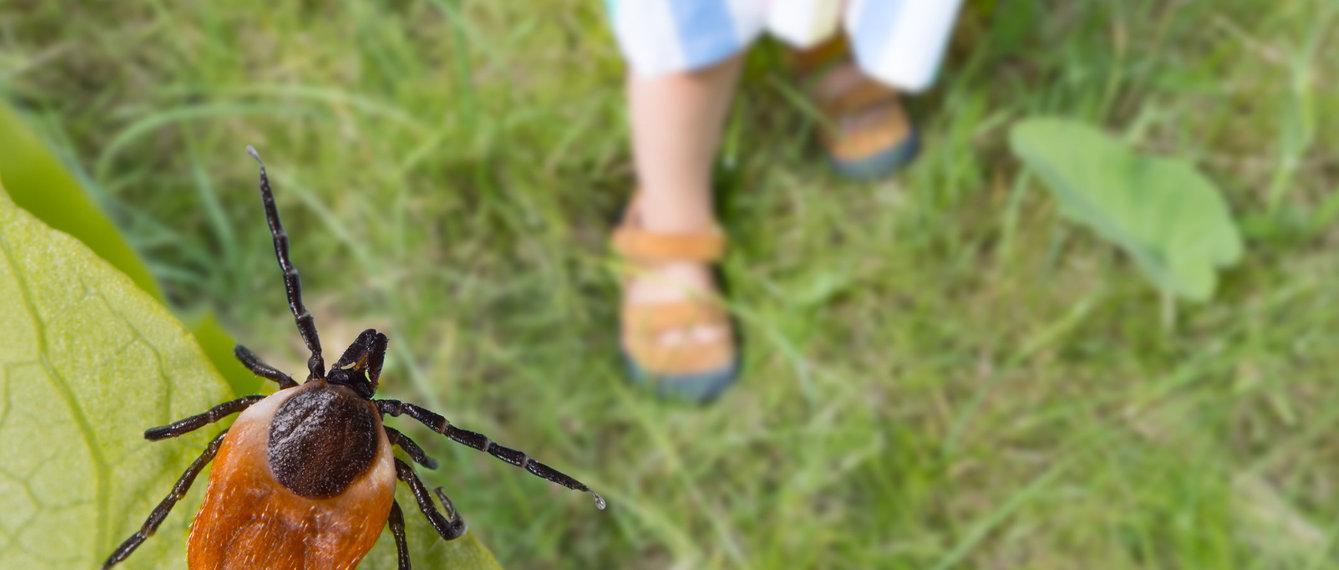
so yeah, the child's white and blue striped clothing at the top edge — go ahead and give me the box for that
[605,0,961,92]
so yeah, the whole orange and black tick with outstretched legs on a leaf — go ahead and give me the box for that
[103,146,605,570]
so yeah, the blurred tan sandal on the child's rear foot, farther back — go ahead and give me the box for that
[791,36,920,181]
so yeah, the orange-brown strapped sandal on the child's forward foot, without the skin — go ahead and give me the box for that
[612,195,740,403]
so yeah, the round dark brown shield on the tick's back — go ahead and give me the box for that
[269,381,379,498]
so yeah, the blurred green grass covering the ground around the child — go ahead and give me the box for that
[0,0,1339,569]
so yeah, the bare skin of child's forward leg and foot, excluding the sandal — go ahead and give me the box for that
[625,56,742,344]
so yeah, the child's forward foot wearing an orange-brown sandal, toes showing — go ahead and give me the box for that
[613,199,739,403]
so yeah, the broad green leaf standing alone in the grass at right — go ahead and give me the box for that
[1010,118,1241,301]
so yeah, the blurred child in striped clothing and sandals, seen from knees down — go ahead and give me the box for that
[608,0,960,401]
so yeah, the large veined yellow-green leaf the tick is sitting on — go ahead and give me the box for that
[0,187,498,569]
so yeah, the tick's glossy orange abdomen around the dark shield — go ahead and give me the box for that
[186,383,395,570]
